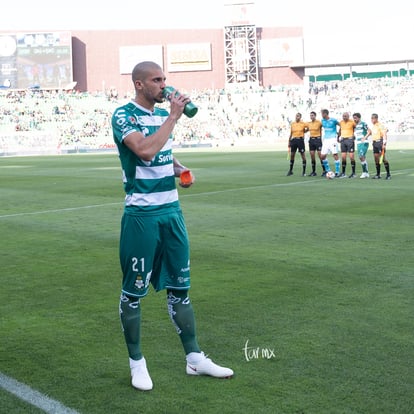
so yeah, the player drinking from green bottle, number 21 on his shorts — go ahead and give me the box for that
[112,62,233,391]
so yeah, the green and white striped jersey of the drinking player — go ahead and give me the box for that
[112,101,179,214]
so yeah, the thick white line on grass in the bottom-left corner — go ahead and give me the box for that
[0,372,79,414]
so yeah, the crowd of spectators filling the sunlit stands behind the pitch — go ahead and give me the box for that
[0,77,414,153]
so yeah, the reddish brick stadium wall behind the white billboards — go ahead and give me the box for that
[72,27,304,95]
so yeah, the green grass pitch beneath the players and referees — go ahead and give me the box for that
[0,150,414,414]
